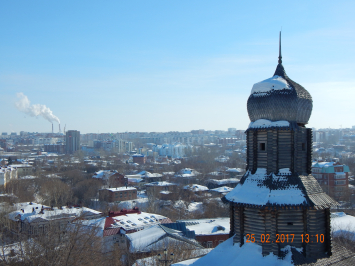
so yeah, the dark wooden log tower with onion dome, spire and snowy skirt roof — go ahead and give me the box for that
[223,33,337,259]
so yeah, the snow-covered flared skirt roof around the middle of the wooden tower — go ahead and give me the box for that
[224,168,338,209]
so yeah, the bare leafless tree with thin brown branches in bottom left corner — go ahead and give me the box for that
[0,221,103,266]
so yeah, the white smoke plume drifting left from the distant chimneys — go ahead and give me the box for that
[15,92,60,123]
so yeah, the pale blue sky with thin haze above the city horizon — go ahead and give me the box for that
[0,0,355,133]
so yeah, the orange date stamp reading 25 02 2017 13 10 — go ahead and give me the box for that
[245,234,324,243]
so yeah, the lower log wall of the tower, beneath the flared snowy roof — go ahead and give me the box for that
[231,206,331,258]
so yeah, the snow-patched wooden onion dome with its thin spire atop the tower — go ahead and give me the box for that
[247,32,313,125]
